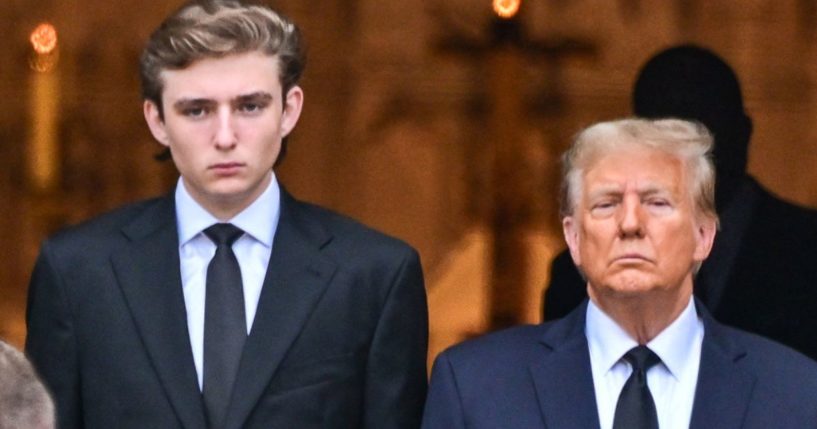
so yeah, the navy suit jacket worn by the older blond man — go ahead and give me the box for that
[422,304,817,429]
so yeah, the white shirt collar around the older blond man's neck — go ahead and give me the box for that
[585,297,703,378]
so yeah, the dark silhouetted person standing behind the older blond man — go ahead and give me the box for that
[543,45,817,359]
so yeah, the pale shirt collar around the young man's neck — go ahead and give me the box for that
[175,172,281,247]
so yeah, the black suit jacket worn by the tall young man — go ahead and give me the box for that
[26,191,428,429]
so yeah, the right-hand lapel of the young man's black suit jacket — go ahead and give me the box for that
[225,189,337,428]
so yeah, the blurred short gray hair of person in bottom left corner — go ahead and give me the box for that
[0,340,56,429]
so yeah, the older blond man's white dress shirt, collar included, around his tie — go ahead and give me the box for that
[585,297,704,429]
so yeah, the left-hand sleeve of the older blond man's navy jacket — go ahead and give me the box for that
[422,352,465,429]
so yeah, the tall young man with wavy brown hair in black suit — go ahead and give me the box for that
[26,1,427,429]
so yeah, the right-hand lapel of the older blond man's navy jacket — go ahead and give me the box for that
[689,303,755,429]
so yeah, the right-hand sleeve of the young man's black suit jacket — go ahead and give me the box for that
[364,250,428,429]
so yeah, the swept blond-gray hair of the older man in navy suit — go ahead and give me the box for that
[560,118,718,223]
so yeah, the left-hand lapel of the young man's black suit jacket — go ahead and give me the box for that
[111,195,205,429]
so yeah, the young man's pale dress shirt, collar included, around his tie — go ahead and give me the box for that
[176,173,281,389]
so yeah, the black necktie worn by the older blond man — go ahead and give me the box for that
[613,346,661,429]
